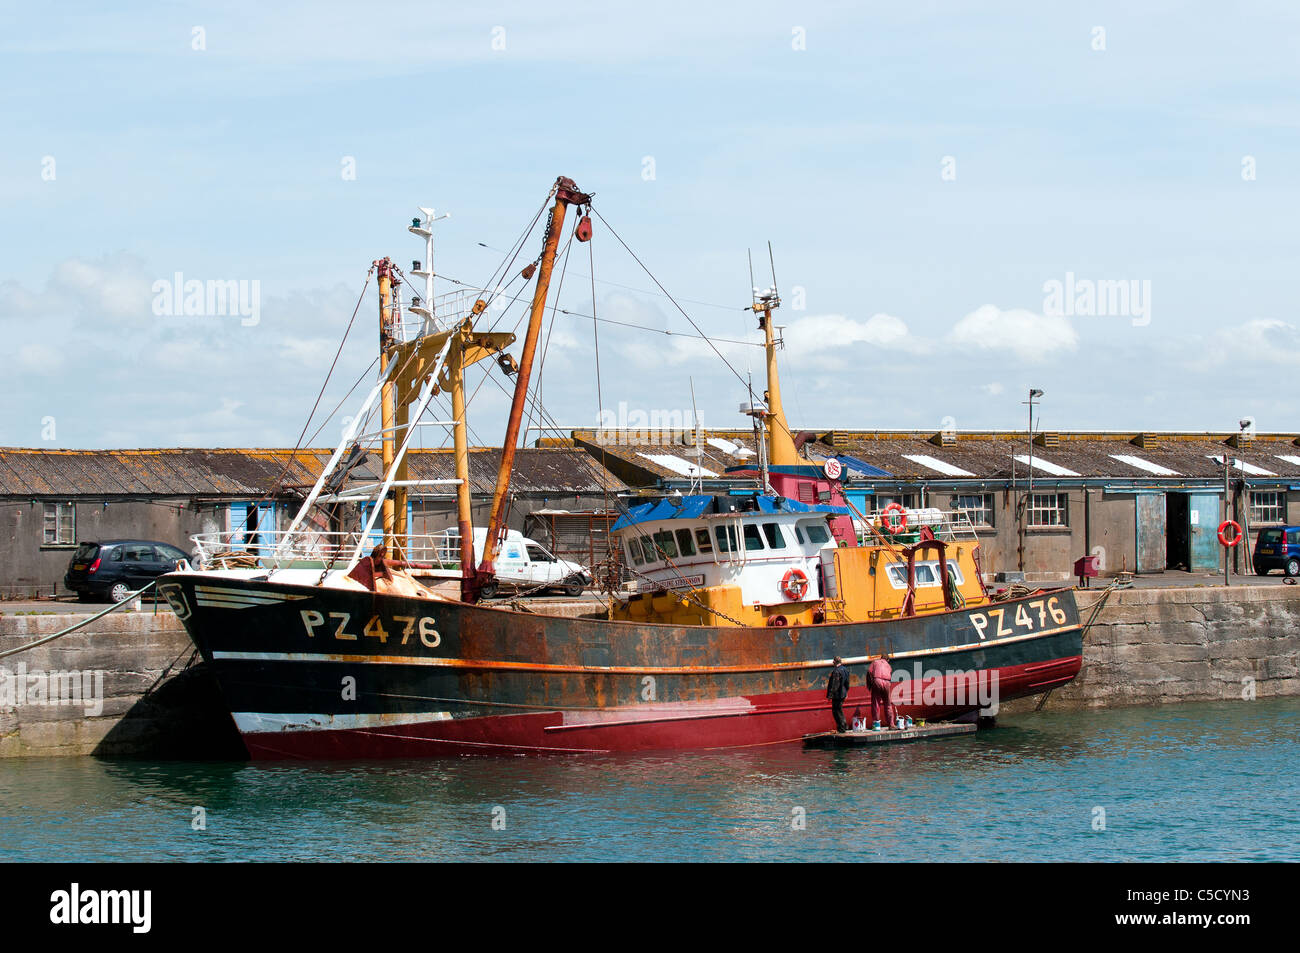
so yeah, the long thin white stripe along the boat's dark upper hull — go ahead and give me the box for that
[212,625,1079,675]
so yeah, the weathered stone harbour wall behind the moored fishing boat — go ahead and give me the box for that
[0,585,1300,759]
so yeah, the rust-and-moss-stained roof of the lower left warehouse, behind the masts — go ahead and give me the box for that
[0,447,625,498]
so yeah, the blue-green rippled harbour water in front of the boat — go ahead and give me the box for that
[0,698,1300,861]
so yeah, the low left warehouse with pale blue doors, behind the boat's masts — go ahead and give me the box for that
[0,447,627,597]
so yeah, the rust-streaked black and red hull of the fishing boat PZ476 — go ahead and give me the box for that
[160,572,1082,758]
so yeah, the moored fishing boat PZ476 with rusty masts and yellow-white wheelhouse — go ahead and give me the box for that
[159,178,1082,758]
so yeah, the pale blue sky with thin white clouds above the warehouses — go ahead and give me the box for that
[0,0,1300,449]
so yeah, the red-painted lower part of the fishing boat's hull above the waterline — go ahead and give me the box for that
[243,655,1083,759]
